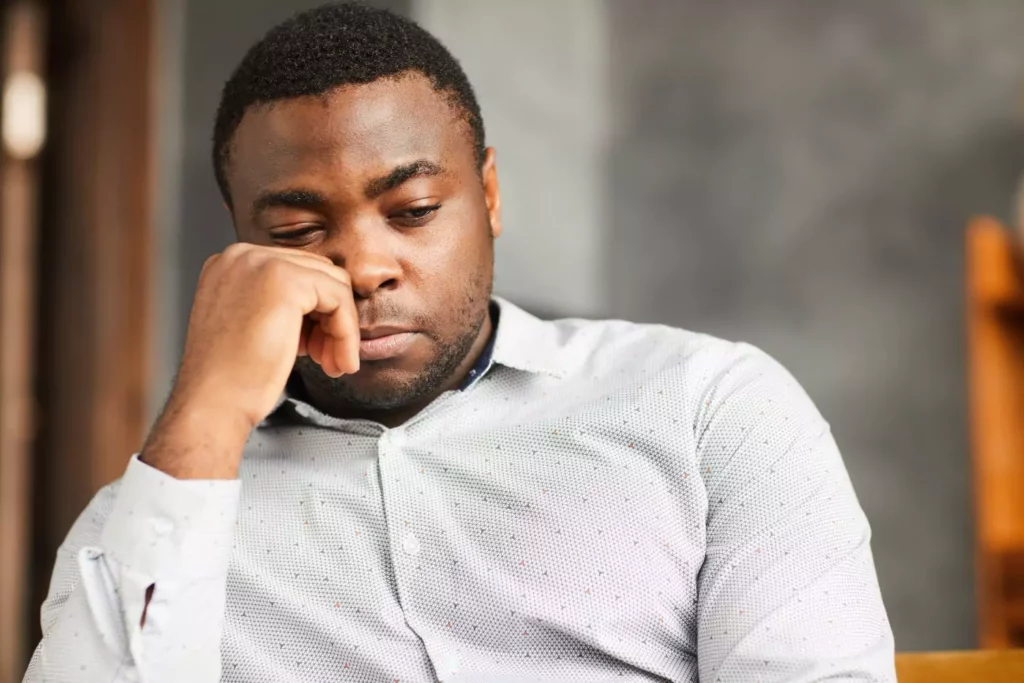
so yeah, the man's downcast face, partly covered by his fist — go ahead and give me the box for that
[226,74,501,412]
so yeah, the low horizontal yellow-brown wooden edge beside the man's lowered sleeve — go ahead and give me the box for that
[896,650,1024,683]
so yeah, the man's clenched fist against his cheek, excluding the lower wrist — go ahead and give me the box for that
[171,244,359,429]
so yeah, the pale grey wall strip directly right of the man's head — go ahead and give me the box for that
[412,0,611,315]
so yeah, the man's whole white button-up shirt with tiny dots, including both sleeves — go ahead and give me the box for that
[26,302,895,683]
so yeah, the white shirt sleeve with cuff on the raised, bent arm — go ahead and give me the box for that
[25,457,241,683]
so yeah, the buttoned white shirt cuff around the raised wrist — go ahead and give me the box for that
[100,455,242,581]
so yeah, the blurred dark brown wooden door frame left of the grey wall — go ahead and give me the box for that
[16,0,159,680]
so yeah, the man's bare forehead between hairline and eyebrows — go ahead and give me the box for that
[226,74,475,200]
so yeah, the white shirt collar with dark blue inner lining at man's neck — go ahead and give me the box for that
[261,297,567,426]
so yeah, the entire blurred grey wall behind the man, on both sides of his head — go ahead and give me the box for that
[157,0,1024,649]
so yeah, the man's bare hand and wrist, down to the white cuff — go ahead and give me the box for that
[141,244,359,478]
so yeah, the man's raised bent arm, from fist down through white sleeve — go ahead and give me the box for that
[26,244,359,683]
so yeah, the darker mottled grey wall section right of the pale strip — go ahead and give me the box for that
[607,0,1024,649]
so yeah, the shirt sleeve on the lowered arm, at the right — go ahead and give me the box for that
[694,345,896,681]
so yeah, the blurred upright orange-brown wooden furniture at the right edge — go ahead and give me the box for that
[962,217,1024,647]
